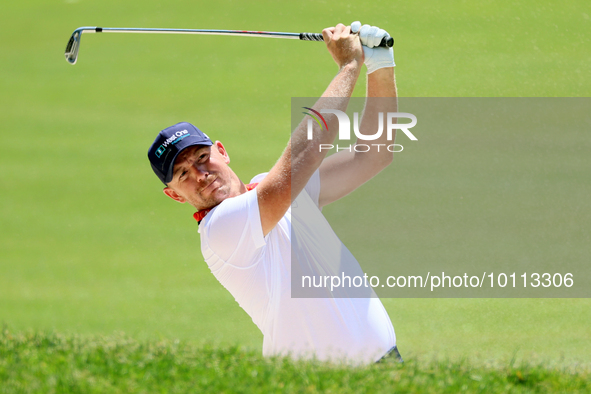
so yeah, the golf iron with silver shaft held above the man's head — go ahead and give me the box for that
[65,26,394,64]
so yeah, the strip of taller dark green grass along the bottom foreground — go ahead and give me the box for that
[0,329,591,393]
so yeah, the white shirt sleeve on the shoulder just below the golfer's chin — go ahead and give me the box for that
[199,190,266,267]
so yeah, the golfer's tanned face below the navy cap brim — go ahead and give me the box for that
[164,141,242,210]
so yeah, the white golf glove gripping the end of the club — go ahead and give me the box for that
[351,21,396,74]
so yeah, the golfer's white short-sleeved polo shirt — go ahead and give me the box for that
[199,171,396,363]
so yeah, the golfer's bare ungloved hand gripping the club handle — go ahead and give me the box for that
[322,23,363,68]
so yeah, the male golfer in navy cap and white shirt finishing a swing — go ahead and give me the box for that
[148,22,400,363]
